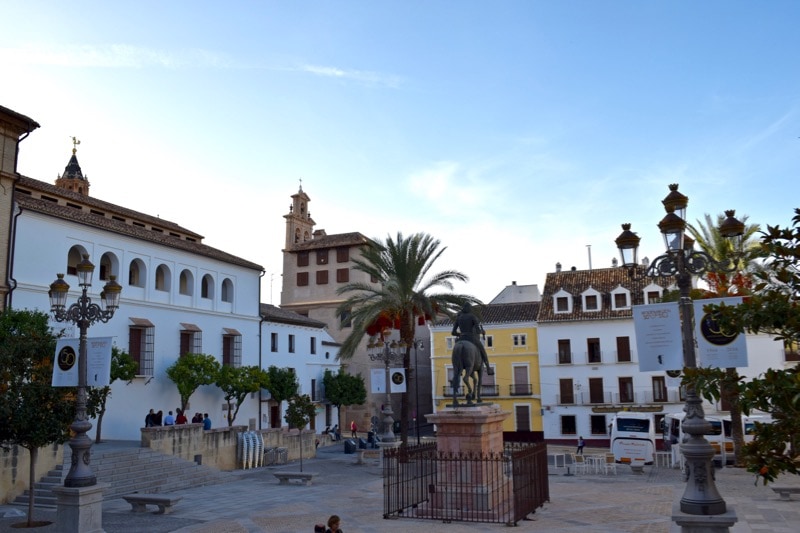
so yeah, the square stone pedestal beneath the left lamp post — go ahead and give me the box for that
[53,483,108,533]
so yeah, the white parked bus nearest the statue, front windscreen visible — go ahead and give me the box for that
[611,411,656,464]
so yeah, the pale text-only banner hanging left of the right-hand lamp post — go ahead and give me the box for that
[633,302,683,372]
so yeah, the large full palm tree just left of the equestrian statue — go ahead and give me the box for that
[337,232,481,445]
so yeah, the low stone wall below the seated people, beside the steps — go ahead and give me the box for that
[141,424,316,470]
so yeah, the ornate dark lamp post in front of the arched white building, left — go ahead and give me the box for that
[48,255,122,487]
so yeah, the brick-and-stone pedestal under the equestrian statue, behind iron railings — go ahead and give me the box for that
[418,405,513,522]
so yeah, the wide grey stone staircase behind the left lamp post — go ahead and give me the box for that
[13,446,238,509]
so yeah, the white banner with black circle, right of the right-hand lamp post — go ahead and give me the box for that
[693,296,747,368]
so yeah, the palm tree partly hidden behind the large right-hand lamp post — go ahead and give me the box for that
[687,213,761,466]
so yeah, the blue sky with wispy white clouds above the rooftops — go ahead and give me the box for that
[0,0,800,305]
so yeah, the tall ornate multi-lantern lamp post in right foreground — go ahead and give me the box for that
[616,184,744,515]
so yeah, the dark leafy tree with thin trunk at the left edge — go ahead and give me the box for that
[0,309,75,527]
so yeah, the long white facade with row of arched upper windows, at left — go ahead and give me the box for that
[11,209,260,440]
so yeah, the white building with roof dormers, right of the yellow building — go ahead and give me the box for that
[538,266,786,446]
